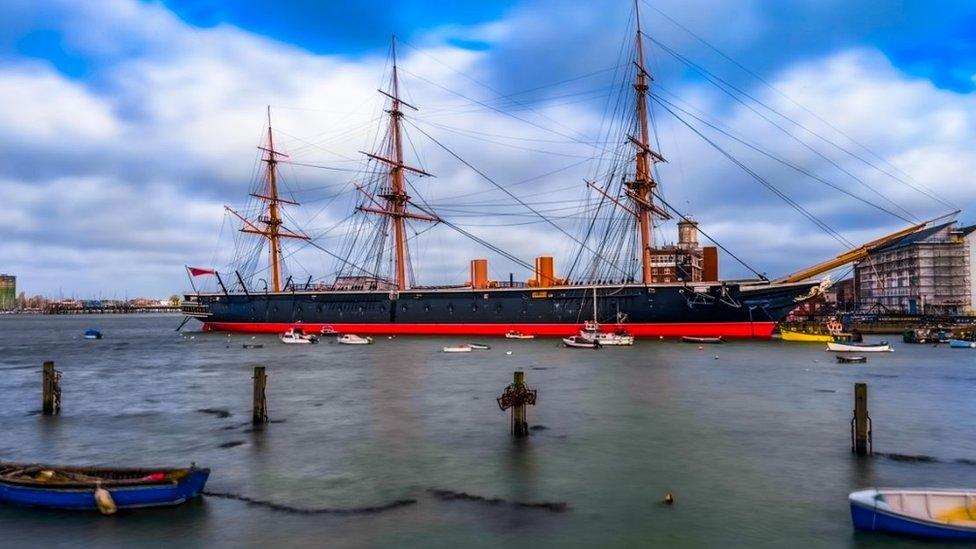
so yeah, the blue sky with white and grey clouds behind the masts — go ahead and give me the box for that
[0,0,976,297]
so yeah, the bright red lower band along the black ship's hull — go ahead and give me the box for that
[203,322,776,338]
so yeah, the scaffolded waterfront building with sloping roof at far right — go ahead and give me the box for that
[854,221,976,315]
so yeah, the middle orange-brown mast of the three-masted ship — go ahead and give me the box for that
[358,36,440,290]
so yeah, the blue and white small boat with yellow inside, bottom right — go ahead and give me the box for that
[848,489,976,542]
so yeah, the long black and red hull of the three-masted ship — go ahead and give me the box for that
[183,281,817,338]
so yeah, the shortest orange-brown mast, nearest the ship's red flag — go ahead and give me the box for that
[224,106,310,292]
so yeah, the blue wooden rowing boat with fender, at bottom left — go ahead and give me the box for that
[0,463,210,514]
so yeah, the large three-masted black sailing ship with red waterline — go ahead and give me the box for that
[182,8,924,338]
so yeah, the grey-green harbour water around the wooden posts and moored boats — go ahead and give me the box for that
[0,315,976,547]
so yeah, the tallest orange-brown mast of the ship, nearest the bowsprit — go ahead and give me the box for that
[626,4,670,284]
